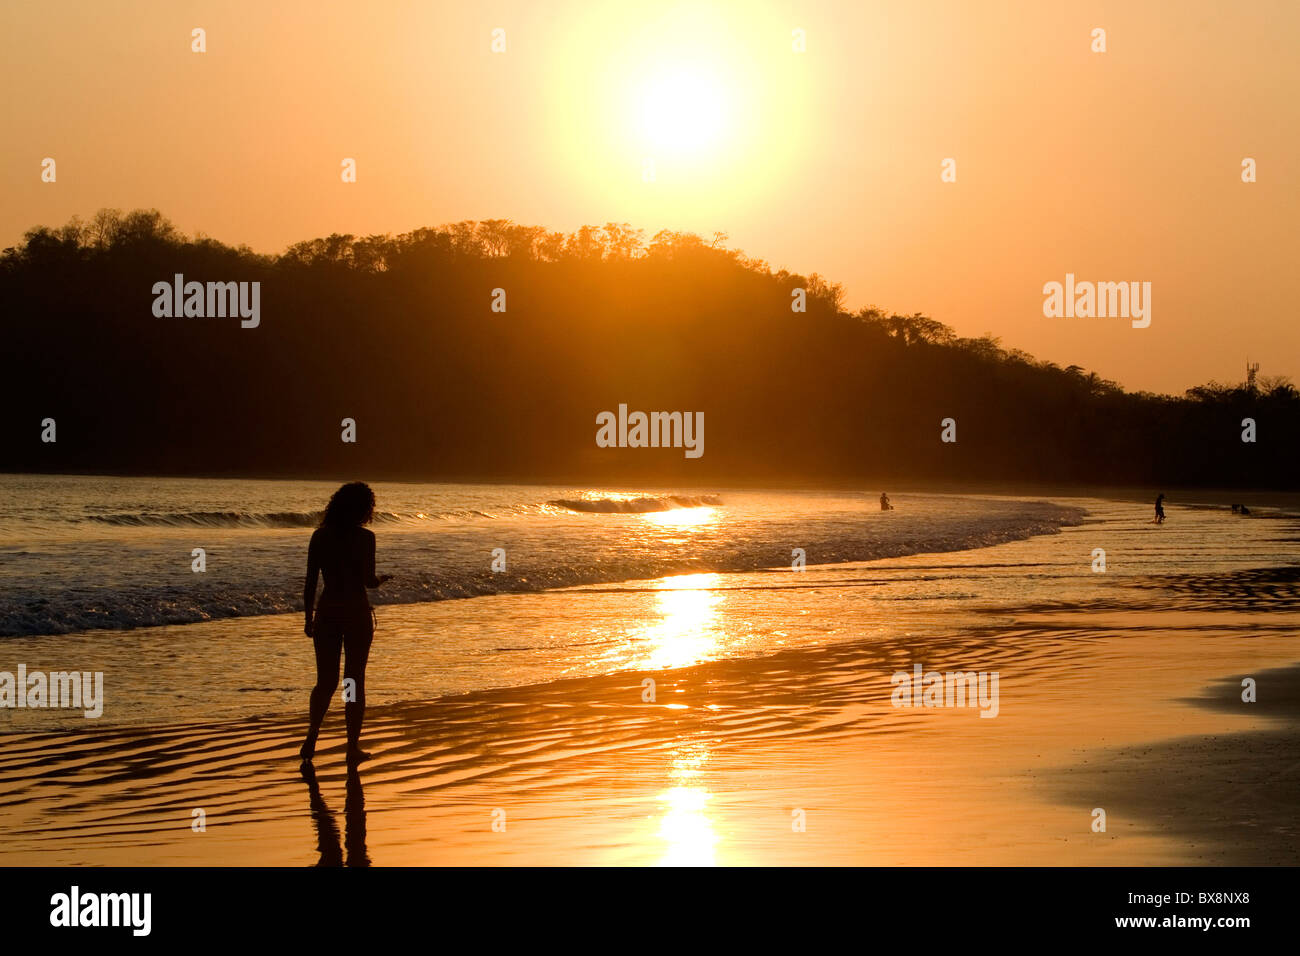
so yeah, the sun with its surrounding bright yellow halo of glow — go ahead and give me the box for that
[540,0,811,209]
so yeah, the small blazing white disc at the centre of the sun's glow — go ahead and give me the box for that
[638,64,728,156]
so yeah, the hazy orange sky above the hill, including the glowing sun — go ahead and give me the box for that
[0,0,1300,392]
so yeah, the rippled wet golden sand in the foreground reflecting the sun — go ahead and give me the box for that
[0,616,1300,865]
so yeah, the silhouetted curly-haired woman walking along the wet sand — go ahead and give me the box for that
[300,481,393,765]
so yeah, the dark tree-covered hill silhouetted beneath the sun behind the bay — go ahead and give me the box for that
[0,209,1300,488]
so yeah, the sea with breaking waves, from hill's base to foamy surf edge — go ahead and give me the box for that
[0,475,1079,636]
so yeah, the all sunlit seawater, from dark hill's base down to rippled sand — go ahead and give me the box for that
[0,476,1295,731]
